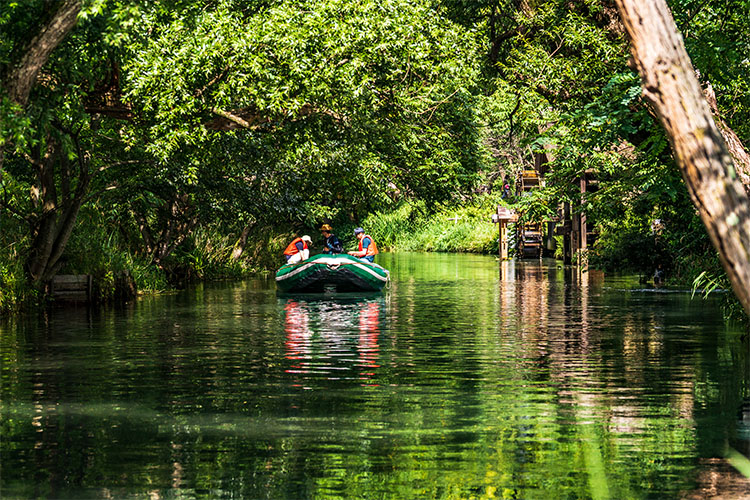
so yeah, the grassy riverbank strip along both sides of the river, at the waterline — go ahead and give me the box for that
[0,195,746,330]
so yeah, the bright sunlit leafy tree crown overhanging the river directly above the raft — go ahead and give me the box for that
[126,0,479,223]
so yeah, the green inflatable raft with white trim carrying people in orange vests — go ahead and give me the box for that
[276,254,390,293]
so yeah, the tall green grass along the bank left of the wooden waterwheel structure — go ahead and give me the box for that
[0,198,508,312]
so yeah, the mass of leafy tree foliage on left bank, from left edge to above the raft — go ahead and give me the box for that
[0,0,488,300]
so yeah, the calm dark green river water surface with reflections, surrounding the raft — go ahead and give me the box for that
[0,254,750,499]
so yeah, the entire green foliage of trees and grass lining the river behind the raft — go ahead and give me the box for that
[0,0,750,322]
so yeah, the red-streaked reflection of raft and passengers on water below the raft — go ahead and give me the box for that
[280,294,385,385]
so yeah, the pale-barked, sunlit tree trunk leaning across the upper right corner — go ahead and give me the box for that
[617,0,750,315]
